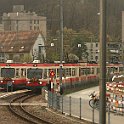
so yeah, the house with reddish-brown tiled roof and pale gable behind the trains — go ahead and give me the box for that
[0,31,46,62]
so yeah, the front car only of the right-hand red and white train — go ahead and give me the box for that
[26,64,79,89]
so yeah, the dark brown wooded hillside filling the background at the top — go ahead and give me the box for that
[0,0,124,39]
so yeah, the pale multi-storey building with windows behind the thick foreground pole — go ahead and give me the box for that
[86,41,122,63]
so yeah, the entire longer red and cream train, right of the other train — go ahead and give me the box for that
[26,63,123,90]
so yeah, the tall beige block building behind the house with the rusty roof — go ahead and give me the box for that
[2,5,46,38]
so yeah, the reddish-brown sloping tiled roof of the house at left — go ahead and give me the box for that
[0,31,42,53]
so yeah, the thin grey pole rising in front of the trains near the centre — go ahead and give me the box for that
[60,0,63,86]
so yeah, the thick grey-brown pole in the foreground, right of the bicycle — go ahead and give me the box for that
[99,0,106,124]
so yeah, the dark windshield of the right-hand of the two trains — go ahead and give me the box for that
[27,68,42,79]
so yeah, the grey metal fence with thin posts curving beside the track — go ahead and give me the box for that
[46,91,123,124]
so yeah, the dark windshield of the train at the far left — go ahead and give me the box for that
[1,68,15,78]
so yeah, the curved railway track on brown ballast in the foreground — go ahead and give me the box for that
[9,93,53,124]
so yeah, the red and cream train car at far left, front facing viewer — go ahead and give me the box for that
[0,63,26,89]
